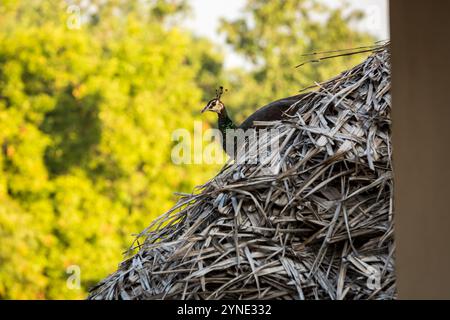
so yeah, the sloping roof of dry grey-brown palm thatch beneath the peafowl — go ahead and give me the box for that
[89,45,396,299]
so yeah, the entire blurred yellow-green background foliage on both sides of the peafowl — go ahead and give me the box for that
[0,0,378,299]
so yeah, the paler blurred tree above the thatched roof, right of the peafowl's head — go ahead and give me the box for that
[220,0,374,120]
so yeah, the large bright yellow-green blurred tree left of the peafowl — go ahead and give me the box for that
[0,1,218,298]
